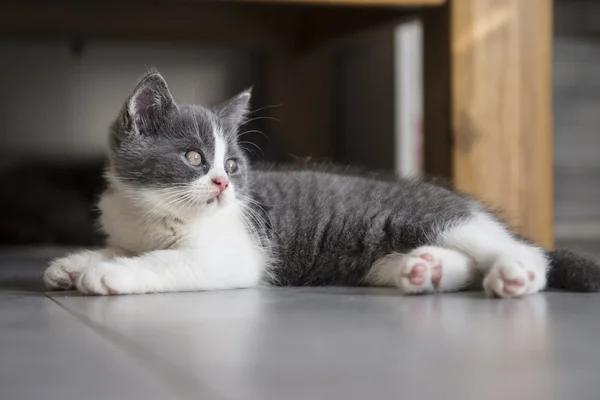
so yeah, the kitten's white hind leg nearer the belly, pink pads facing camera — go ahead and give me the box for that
[367,246,478,294]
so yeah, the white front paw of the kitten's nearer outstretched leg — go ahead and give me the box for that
[76,261,143,295]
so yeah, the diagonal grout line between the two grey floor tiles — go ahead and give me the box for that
[44,292,230,400]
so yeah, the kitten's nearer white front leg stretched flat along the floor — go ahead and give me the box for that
[76,248,264,295]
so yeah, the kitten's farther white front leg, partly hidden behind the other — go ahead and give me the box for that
[44,248,121,290]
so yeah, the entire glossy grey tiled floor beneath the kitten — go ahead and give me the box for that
[0,248,600,400]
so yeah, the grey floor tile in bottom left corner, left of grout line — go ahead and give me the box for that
[0,289,177,400]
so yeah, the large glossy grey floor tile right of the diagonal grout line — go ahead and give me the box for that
[53,288,600,400]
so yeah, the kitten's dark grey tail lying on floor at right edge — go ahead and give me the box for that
[547,250,600,292]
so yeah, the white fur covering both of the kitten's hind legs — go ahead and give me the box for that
[367,211,549,297]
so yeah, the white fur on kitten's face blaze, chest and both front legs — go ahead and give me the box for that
[44,126,269,294]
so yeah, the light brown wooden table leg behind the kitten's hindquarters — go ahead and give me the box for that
[424,0,553,247]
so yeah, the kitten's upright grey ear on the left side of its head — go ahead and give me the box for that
[124,71,177,135]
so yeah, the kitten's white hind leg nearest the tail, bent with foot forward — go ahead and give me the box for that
[437,212,549,297]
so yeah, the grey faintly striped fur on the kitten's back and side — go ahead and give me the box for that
[250,166,476,286]
